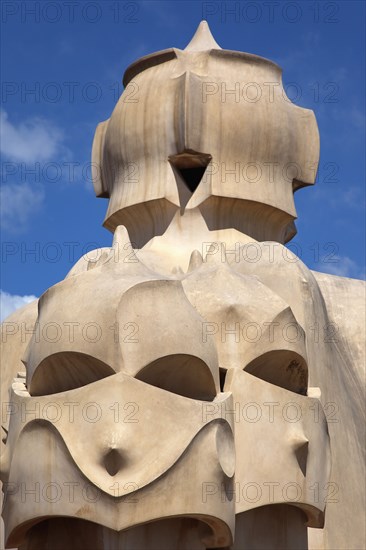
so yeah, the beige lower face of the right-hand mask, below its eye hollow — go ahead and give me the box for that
[225,369,330,527]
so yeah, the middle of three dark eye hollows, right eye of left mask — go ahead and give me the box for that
[136,353,216,401]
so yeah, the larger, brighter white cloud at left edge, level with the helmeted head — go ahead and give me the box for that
[0,111,63,163]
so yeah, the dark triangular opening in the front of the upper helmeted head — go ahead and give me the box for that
[169,150,212,193]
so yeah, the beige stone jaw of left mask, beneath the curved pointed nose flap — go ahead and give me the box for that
[4,406,234,547]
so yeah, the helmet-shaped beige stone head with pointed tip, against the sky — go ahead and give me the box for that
[93,22,319,248]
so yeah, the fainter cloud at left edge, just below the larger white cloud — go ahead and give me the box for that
[0,183,45,233]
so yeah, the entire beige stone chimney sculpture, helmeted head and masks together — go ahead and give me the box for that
[2,22,364,550]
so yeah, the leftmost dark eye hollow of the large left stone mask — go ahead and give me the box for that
[28,351,115,396]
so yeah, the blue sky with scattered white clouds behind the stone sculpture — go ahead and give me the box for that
[1,0,365,317]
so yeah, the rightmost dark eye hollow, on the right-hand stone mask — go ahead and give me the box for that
[244,350,308,395]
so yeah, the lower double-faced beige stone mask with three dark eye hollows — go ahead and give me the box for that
[0,234,329,547]
